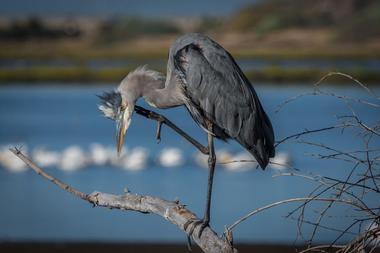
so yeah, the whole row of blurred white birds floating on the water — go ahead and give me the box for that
[0,143,291,172]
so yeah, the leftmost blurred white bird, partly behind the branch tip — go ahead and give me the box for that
[0,145,28,172]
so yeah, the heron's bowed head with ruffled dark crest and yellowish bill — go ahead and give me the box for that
[99,91,134,155]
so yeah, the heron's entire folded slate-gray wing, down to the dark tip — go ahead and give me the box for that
[171,36,274,167]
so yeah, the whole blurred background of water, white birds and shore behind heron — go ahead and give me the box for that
[0,0,380,252]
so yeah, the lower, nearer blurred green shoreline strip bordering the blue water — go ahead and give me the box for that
[0,67,380,86]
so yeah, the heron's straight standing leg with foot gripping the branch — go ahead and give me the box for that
[184,123,216,237]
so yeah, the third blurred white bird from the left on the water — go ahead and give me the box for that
[59,145,89,171]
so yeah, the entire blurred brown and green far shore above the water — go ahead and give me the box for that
[0,0,380,84]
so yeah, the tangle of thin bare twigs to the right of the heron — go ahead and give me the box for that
[225,72,380,253]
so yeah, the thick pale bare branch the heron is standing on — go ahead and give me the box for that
[10,148,237,253]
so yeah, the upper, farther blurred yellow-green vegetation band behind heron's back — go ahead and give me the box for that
[0,41,380,61]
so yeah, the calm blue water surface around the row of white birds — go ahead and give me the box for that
[0,84,380,243]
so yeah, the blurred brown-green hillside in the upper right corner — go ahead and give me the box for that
[226,0,380,41]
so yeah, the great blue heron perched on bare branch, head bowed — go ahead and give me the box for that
[99,34,275,236]
